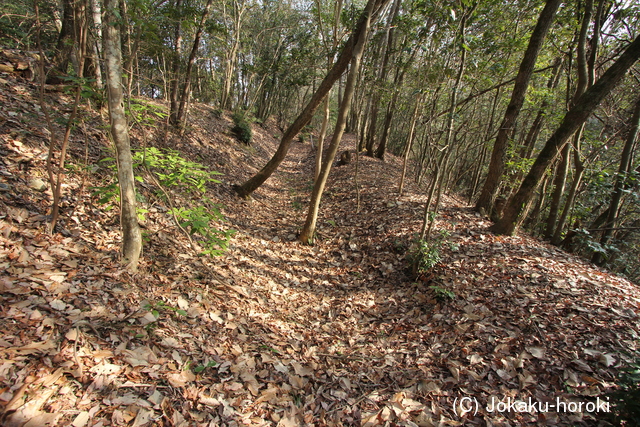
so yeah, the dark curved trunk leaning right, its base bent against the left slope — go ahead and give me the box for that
[235,0,389,197]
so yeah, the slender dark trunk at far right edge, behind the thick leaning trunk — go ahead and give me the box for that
[592,98,640,265]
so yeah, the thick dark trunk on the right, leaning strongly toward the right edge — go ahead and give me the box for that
[491,36,640,235]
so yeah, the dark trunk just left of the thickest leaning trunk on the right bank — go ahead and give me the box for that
[476,0,560,212]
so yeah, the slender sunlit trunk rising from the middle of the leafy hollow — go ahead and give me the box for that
[300,1,375,244]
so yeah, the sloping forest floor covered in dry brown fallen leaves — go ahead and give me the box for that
[0,63,640,427]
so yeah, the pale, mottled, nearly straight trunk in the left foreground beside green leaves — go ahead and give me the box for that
[103,0,142,271]
